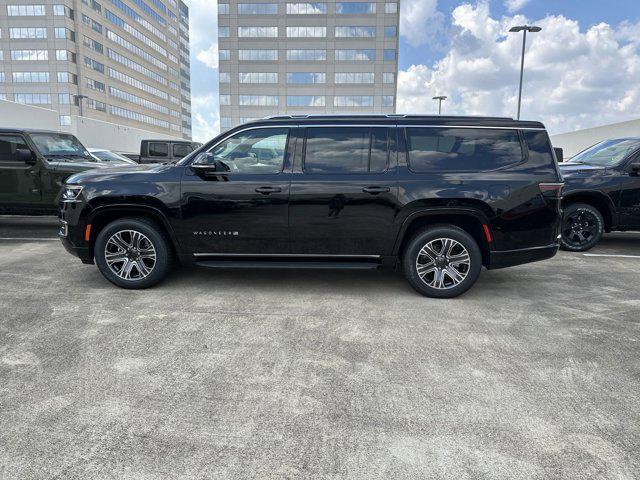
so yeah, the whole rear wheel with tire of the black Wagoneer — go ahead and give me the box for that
[402,225,482,298]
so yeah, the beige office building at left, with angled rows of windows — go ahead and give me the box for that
[0,0,191,139]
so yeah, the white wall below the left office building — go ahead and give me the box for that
[0,100,183,154]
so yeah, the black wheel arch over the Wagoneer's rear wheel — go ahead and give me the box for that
[393,208,491,266]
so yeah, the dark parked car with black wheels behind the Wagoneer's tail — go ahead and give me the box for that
[560,137,640,252]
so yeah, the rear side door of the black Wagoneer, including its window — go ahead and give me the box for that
[289,125,398,256]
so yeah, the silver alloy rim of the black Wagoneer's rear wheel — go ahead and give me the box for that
[416,238,471,290]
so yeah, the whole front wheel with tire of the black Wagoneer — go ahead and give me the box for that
[94,218,172,289]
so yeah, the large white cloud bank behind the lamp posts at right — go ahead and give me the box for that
[397,2,640,133]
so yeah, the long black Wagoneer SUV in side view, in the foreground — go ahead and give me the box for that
[60,115,562,297]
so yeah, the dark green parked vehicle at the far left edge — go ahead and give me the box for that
[0,129,106,215]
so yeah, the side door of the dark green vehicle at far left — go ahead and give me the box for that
[0,133,42,209]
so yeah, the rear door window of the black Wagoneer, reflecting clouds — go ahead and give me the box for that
[304,126,388,174]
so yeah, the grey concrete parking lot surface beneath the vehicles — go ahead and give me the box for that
[0,217,640,480]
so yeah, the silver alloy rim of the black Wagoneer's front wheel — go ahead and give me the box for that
[104,230,156,280]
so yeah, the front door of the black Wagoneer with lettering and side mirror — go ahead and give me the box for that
[179,126,295,257]
